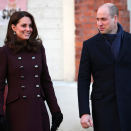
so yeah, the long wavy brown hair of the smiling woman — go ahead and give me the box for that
[4,11,42,52]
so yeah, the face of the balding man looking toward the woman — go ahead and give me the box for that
[97,7,117,34]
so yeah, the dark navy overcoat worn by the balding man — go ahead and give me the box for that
[78,31,131,131]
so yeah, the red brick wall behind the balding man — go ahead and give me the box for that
[75,0,130,80]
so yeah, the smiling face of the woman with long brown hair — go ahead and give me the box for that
[12,17,33,40]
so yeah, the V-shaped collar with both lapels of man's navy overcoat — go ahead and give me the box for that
[97,31,131,63]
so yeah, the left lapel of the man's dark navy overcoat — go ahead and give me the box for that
[97,33,116,63]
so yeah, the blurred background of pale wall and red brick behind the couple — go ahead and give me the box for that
[0,0,131,131]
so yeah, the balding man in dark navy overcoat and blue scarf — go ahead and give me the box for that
[78,3,131,131]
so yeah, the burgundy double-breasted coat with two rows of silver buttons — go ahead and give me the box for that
[0,45,60,131]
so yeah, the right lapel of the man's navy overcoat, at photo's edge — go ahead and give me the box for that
[116,32,131,62]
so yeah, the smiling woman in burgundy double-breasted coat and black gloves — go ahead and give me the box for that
[0,11,63,131]
